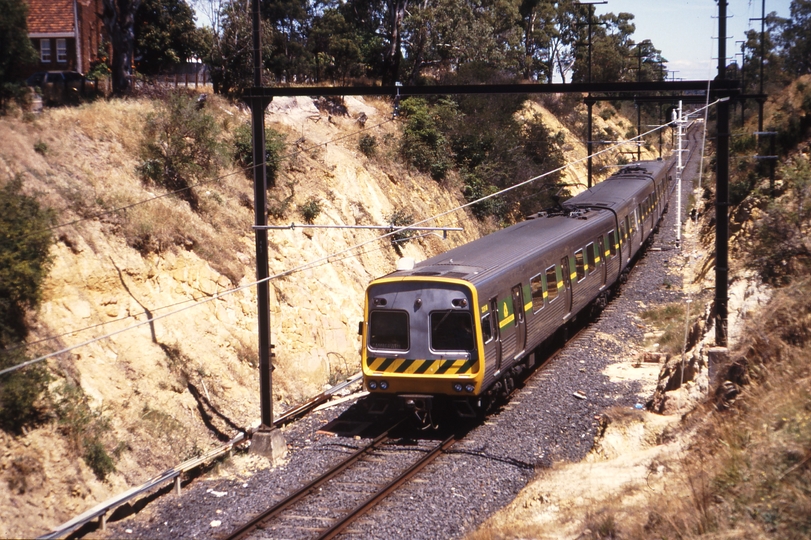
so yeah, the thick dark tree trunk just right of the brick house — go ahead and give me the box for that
[101,0,141,96]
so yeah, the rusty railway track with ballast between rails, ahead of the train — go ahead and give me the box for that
[225,420,461,540]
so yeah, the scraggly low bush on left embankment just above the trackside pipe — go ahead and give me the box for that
[54,382,116,480]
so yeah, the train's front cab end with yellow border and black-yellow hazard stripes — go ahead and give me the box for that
[361,276,484,420]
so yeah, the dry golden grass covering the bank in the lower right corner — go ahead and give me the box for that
[622,281,811,539]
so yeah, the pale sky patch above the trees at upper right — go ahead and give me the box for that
[604,0,791,80]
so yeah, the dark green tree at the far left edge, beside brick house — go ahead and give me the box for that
[0,0,37,109]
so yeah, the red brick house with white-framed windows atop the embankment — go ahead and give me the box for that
[28,0,109,73]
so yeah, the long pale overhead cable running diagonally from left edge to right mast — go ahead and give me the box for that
[0,98,723,375]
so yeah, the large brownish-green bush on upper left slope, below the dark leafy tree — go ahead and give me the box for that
[138,93,222,210]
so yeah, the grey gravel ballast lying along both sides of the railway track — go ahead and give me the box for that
[98,136,698,540]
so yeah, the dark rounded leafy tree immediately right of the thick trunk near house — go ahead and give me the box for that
[135,0,208,75]
